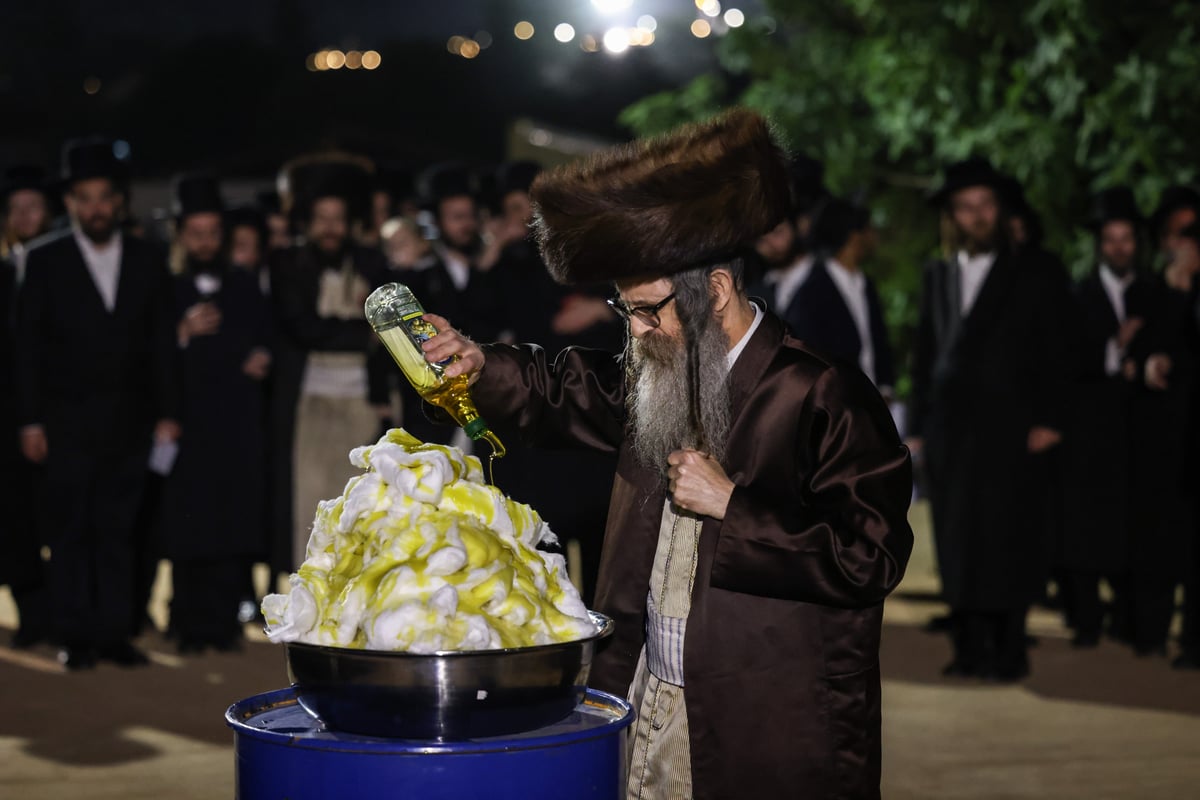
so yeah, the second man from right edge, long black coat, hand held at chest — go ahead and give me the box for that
[1055,187,1153,646]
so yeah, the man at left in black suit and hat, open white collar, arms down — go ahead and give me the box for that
[17,140,179,669]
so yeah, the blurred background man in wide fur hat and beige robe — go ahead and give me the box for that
[270,155,395,570]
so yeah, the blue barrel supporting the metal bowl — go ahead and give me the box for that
[226,688,634,800]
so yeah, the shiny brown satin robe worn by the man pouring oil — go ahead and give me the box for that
[473,313,912,800]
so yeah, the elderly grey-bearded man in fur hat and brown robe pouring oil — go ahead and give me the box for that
[425,110,912,799]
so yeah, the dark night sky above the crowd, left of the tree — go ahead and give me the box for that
[0,0,761,176]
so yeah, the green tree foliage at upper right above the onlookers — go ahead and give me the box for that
[622,0,1200,391]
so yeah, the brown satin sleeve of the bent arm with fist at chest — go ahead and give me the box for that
[712,369,913,608]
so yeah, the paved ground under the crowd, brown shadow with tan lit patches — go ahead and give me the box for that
[0,509,1200,800]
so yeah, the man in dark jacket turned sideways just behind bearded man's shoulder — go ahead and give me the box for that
[780,198,895,397]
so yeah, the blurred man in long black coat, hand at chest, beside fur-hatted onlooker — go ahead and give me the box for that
[163,175,271,654]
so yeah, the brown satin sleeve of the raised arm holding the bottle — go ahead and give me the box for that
[470,344,625,452]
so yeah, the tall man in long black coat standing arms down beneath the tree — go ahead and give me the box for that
[910,160,1063,681]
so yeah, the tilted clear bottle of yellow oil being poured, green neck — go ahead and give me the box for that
[365,283,506,483]
